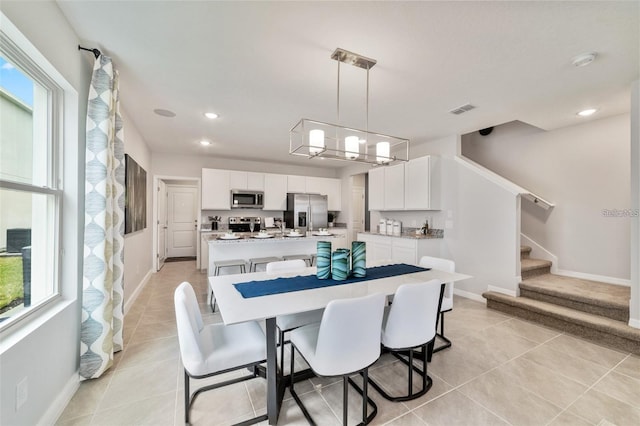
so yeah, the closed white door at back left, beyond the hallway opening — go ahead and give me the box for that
[167,185,198,257]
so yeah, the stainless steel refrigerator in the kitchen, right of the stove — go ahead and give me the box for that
[284,193,327,231]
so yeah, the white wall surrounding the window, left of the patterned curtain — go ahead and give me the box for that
[0,0,91,425]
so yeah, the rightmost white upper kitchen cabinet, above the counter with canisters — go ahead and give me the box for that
[404,155,440,210]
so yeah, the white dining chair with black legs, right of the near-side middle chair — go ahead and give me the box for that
[369,280,445,402]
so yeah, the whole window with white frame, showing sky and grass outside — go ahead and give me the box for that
[0,32,64,330]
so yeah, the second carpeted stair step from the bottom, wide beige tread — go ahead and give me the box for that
[520,274,631,324]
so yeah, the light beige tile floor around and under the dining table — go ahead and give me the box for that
[57,261,640,426]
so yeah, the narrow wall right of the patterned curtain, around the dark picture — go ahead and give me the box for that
[120,110,153,306]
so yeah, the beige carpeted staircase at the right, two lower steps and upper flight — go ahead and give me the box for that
[483,246,640,355]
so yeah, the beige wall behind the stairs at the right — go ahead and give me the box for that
[462,114,630,280]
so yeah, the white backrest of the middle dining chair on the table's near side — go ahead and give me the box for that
[312,293,385,376]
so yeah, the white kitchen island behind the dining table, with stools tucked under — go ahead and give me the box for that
[205,233,346,276]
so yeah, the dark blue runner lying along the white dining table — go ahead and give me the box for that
[234,263,431,299]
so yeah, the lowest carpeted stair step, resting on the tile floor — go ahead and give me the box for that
[482,291,640,355]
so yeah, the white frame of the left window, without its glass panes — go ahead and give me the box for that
[0,26,66,334]
